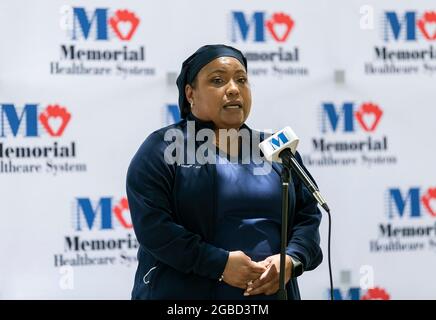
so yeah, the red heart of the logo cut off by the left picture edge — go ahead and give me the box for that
[39,104,71,137]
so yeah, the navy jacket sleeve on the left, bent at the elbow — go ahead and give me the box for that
[126,132,229,279]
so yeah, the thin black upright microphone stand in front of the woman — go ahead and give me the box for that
[277,162,289,300]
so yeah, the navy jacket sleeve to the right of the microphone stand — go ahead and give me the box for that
[286,152,323,271]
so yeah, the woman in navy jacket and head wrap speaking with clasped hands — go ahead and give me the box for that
[127,45,322,299]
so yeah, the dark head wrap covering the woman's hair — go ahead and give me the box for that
[176,44,247,119]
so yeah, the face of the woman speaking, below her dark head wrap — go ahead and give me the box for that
[185,57,251,129]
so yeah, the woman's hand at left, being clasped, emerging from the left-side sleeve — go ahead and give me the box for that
[223,251,267,289]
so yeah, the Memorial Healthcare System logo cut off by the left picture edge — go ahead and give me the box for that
[0,103,87,175]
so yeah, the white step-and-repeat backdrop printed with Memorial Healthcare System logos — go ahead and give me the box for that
[0,0,436,299]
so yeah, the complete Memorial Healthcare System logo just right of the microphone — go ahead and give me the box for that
[303,101,397,167]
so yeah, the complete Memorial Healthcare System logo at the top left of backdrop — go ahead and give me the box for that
[49,5,155,79]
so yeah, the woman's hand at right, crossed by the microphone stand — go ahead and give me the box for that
[244,254,292,296]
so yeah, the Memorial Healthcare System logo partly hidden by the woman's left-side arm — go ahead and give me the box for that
[54,196,139,267]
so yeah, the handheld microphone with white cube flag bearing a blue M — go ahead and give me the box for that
[259,126,330,212]
